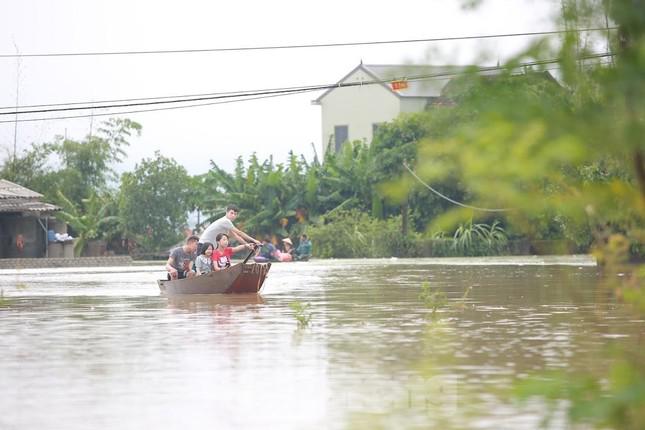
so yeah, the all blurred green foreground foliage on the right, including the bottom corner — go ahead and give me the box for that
[432,0,645,429]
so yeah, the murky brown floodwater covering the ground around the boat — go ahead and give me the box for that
[0,256,645,430]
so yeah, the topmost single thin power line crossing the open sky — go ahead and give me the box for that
[0,27,618,58]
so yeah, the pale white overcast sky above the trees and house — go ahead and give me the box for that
[0,0,560,174]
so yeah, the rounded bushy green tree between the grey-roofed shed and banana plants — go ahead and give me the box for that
[119,152,193,251]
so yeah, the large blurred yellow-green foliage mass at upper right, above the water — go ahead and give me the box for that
[408,1,645,266]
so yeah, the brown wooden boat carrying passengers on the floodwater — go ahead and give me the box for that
[157,263,271,296]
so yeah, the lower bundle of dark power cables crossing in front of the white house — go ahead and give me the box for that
[0,53,614,124]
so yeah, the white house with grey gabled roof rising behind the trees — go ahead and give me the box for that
[312,63,465,154]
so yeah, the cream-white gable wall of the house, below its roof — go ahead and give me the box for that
[320,69,400,154]
